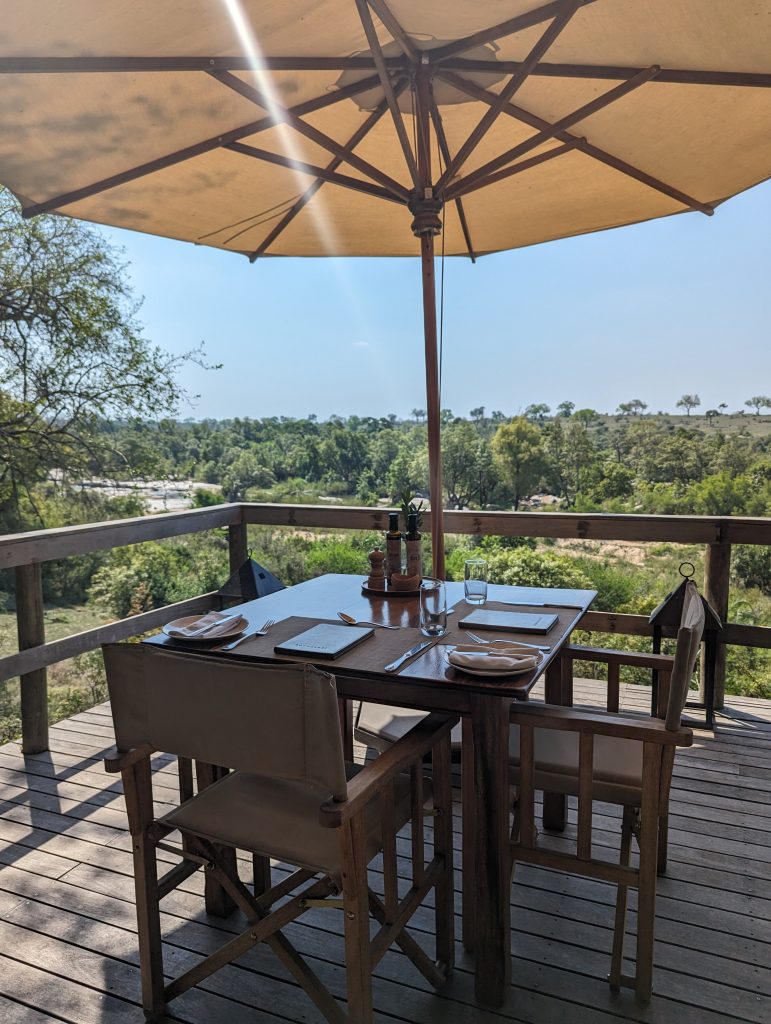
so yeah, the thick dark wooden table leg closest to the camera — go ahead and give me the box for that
[464,694,511,1007]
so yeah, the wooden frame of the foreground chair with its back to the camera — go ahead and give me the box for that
[104,714,457,1024]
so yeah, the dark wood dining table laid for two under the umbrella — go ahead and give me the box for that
[146,573,596,1007]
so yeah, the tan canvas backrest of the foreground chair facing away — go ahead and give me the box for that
[102,644,347,800]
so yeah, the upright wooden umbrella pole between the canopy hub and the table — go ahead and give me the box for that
[420,233,444,580]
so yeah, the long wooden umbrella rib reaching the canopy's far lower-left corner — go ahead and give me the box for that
[22,75,387,218]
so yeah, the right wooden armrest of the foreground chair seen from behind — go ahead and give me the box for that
[320,712,458,828]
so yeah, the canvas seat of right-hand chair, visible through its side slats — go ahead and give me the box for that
[509,725,643,807]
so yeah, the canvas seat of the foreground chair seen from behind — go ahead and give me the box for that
[160,762,417,881]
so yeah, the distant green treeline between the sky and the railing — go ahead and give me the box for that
[79,403,771,515]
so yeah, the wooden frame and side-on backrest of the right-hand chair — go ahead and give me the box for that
[510,586,704,1001]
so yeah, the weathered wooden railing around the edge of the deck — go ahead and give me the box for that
[0,503,771,753]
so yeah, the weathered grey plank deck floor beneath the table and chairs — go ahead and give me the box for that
[0,681,771,1024]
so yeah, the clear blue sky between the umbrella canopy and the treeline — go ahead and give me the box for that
[100,182,771,419]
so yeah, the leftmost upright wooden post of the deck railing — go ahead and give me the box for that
[16,564,48,754]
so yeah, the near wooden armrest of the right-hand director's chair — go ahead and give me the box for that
[509,703,693,746]
